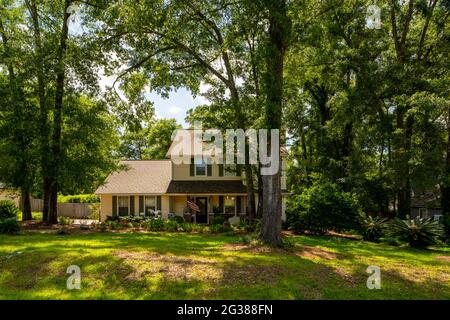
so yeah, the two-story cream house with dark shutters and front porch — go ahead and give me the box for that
[95,132,287,223]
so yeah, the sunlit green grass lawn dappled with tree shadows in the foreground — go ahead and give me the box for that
[0,233,450,299]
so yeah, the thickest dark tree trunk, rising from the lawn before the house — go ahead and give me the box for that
[261,0,290,245]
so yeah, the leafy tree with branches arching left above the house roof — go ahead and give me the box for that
[91,0,255,217]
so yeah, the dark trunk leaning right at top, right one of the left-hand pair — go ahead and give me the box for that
[48,0,71,224]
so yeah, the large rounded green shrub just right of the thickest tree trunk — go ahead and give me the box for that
[286,181,361,234]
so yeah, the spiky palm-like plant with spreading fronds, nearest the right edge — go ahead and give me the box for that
[386,217,444,247]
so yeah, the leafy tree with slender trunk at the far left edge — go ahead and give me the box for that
[0,1,35,220]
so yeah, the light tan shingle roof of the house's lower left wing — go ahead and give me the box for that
[95,160,172,194]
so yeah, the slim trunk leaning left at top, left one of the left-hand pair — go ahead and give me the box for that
[26,0,51,222]
